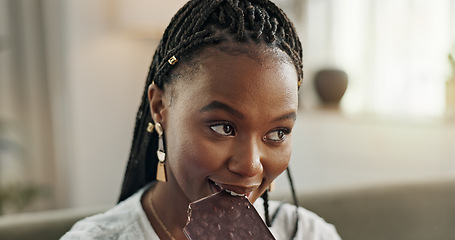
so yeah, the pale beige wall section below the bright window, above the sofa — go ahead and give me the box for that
[270,109,455,199]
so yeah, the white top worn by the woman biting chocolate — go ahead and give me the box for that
[61,185,341,240]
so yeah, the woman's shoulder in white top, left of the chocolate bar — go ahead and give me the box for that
[61,186,154,240]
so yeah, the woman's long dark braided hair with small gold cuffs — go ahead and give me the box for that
[119,0,303,236]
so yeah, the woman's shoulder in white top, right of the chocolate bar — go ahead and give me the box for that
[254,199,341,240]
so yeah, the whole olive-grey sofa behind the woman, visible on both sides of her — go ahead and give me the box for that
[0,180,455,240]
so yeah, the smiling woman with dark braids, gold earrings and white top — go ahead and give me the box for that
[63,0,339,239]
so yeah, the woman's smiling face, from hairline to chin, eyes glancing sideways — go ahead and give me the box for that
[150,44,298,202]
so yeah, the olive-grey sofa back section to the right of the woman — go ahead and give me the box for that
[299,180,455,240]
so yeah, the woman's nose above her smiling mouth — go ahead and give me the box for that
[228,137,263,177]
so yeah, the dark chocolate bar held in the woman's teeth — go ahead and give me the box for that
[183,190,275,240]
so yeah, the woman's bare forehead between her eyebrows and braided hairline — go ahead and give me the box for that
[166,44,298,108]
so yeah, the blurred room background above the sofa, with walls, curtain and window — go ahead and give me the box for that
[0,0,455,218]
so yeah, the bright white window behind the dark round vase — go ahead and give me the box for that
[304,0,455,117]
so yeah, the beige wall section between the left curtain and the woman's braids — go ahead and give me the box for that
[64,0,157,206]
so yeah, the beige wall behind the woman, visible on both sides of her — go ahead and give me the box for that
[61,0,455,206]
